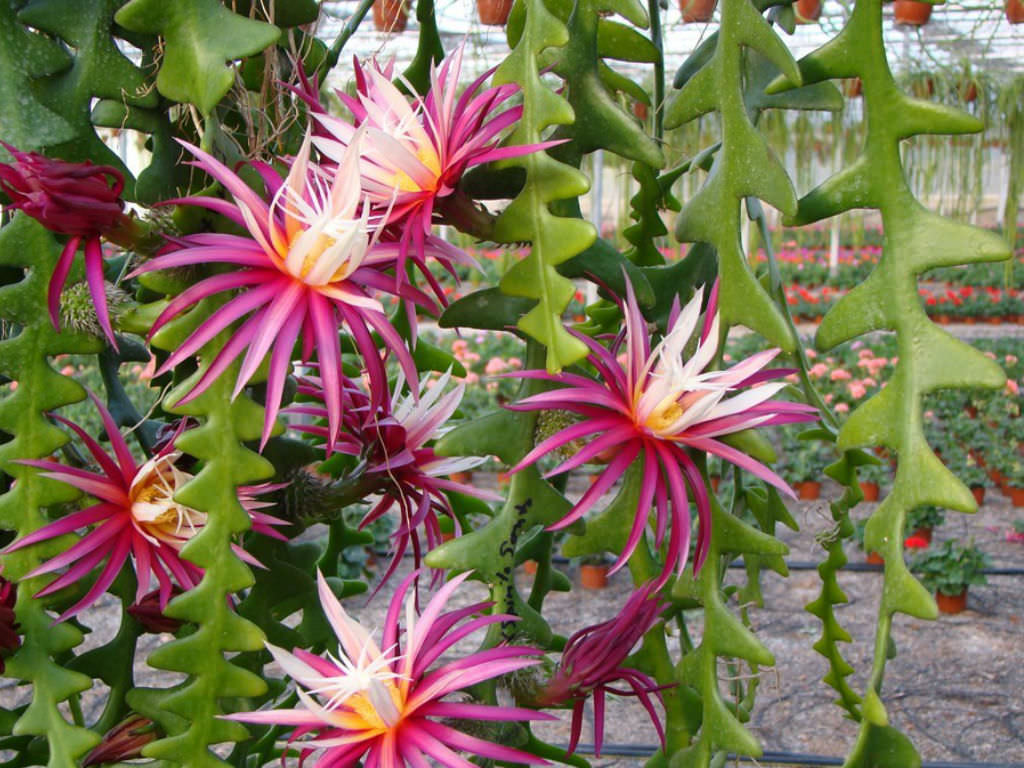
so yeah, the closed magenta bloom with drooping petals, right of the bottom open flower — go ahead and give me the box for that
[537,582,666,757]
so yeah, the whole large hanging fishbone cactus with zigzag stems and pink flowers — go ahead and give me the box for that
[0,6,1022,768]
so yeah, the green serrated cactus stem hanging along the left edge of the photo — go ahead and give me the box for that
[0,213,102,768]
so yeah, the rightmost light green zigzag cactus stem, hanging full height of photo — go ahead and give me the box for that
[769,0,1010,768]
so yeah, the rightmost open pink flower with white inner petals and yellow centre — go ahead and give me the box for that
[509,285,816,581]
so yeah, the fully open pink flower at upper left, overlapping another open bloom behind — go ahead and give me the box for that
[134,135,435,446]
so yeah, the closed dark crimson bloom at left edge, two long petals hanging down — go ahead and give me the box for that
[0,141,127,347]
